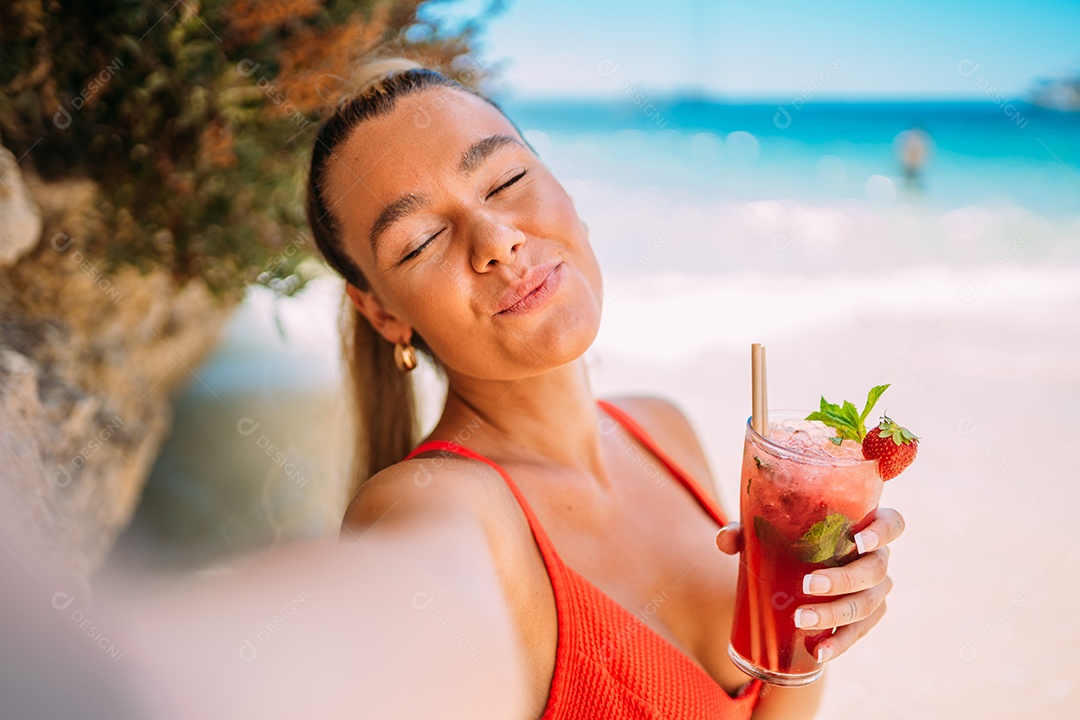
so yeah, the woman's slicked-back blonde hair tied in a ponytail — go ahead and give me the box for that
[307,58,502,498]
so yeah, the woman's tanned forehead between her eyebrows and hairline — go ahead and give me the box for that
[325,87,517,226]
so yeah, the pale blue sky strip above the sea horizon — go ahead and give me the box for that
[426,0,1080,101]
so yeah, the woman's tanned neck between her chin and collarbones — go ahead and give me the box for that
[432,358,607,483]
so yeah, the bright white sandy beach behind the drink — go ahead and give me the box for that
[596,268,1080,719]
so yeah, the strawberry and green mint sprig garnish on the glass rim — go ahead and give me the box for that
[807,385,919,480]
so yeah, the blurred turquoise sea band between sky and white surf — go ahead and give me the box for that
[503,99,1080,217]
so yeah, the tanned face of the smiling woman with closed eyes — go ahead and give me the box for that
[326,87,602,380]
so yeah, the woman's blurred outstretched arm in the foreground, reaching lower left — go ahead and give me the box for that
[97,468,524,719]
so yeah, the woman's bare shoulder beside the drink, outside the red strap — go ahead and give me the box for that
[606,395,717,500]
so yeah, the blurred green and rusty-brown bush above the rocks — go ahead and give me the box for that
[0,0,499,294]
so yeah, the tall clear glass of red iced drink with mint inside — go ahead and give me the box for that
[728,410,882,687]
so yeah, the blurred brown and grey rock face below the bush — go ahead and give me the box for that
[0,147,231,576]
